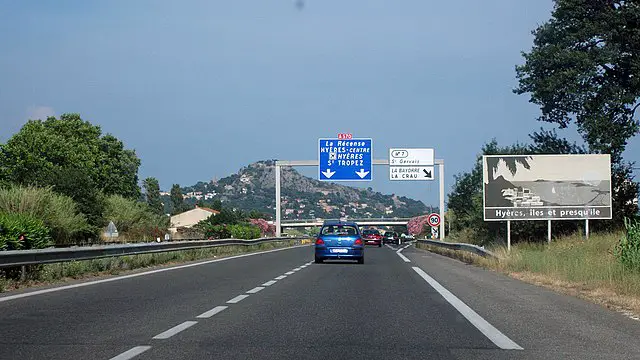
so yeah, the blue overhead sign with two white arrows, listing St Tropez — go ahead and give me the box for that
[318,139,372,181]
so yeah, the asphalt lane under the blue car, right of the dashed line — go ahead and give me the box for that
[135,248,506,359]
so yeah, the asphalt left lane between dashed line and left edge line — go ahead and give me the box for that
[0,246,311,359]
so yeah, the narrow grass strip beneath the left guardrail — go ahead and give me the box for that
[0,239,310,293]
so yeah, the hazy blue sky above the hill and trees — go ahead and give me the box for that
[0,0,640,205]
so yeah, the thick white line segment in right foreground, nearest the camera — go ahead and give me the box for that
[413,266,524,350]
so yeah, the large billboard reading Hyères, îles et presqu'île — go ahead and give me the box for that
[482,154,612,221]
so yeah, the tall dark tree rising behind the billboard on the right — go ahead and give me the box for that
[514,0,640,220]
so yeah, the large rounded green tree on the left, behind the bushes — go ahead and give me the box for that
[0,114,140,226]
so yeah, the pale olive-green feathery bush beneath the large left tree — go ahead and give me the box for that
[0,186,89,244]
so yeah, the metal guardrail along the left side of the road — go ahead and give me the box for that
[0,237,310,268]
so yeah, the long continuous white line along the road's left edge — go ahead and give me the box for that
[0,245,310,302]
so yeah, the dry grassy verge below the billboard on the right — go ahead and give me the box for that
[419,232,640,315]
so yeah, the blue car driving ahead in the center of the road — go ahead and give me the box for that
[314,221,364,264]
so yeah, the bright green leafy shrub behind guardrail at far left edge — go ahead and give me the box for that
[0,213,51,250]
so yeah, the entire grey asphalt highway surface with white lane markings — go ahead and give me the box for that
[0,246,640,360]
